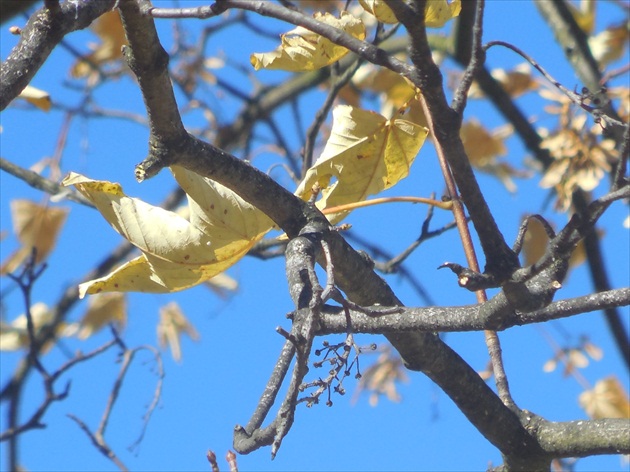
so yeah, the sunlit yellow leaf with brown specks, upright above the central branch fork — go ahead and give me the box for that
[295,105,428,224]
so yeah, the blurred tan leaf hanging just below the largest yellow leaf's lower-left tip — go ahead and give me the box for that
[77,293,127,339]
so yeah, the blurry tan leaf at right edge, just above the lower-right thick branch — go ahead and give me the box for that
[579,376,630,419]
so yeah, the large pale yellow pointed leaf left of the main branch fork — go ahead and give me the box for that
[63,167,273,297]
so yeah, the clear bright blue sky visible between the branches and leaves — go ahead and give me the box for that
[0,0,629,471]
